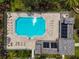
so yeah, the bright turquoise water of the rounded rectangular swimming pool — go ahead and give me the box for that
[15,17,46,37]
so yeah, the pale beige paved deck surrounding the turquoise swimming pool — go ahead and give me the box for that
[7,12,60,49]
